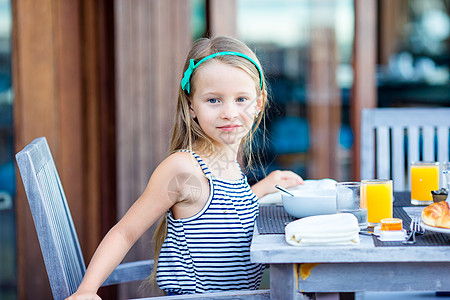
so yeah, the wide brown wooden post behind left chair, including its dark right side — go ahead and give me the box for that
[12,0,115,299]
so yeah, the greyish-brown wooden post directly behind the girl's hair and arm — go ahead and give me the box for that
[115,0,191,299]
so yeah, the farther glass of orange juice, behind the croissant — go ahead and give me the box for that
[411,161,439,205]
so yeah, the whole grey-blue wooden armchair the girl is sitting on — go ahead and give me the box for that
[16,137,270,300]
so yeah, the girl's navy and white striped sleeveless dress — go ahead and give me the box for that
[157,150,264,294]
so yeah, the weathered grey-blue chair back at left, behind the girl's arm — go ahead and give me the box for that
[16,137,86,299]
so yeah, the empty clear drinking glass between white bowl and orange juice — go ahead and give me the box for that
[336,182,368,229]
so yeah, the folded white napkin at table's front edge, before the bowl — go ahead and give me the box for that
[285,213,359,246]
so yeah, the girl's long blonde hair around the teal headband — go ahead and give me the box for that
[151,36,268,283]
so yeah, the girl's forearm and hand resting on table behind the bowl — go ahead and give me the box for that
[252,170,303,198]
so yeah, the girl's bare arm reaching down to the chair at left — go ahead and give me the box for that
[68,156,186,300]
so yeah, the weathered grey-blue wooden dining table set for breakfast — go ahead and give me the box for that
[250,192,450,300]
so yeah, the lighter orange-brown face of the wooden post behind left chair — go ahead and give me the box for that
[12,0,84,299]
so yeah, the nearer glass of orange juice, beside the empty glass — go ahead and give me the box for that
[361,179,393,226]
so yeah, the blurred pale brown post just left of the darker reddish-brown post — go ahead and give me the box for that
[307,27,341,179]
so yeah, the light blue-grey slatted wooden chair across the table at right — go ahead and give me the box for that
[361,108,450,191]
